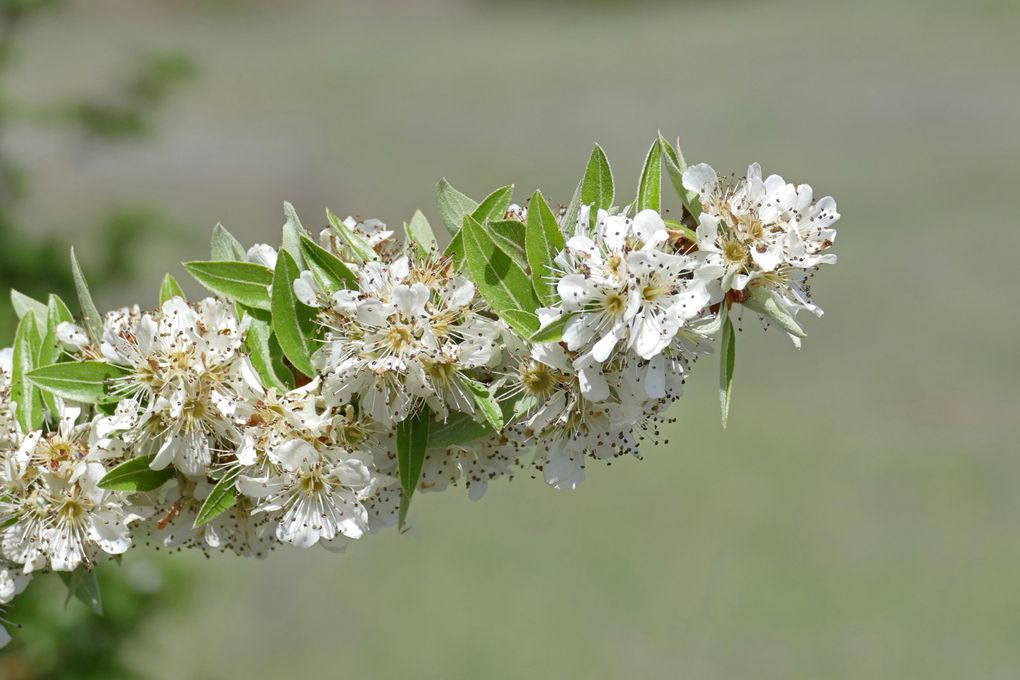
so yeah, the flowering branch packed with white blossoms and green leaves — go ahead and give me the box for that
[0,139,838,644]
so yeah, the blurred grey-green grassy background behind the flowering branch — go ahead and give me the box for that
[4,0,1020,680]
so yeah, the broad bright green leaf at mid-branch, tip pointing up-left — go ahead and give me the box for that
[463,215,540,314]
